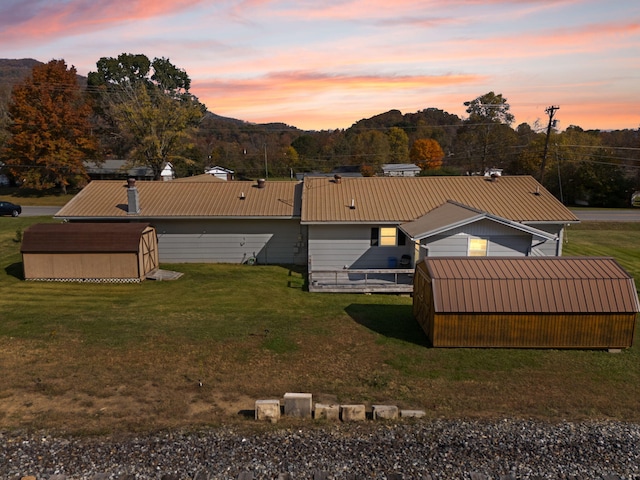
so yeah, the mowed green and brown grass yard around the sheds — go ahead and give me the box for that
[0,218,640,433]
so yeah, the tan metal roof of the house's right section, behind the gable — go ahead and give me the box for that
[301,176,579,223]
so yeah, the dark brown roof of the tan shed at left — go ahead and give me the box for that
[20,223,149,253]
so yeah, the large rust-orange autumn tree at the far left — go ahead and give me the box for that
[2,60,97,192]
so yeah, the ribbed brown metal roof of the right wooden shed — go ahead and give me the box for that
[417,257,640,314]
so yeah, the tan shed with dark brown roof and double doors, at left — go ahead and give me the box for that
[21,223,158,283]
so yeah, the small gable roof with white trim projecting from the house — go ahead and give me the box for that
[400,200,558,240]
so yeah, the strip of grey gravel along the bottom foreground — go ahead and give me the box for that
[0,419,640,480]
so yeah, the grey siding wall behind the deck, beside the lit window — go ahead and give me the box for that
[309,225,413,271]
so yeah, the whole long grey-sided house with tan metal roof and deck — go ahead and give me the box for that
[56,175,578,292]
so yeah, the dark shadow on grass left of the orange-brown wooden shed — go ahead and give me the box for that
[345,303,431,347]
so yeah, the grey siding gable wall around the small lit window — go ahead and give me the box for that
[423,220,544,257]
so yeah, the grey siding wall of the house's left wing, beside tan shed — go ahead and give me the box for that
[153,218,307,265]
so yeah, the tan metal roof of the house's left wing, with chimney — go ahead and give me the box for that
[56,180,302,218]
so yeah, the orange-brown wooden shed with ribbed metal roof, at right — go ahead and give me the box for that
[413,257,640,349]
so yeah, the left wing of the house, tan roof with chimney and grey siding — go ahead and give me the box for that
[56,179,307,265]
